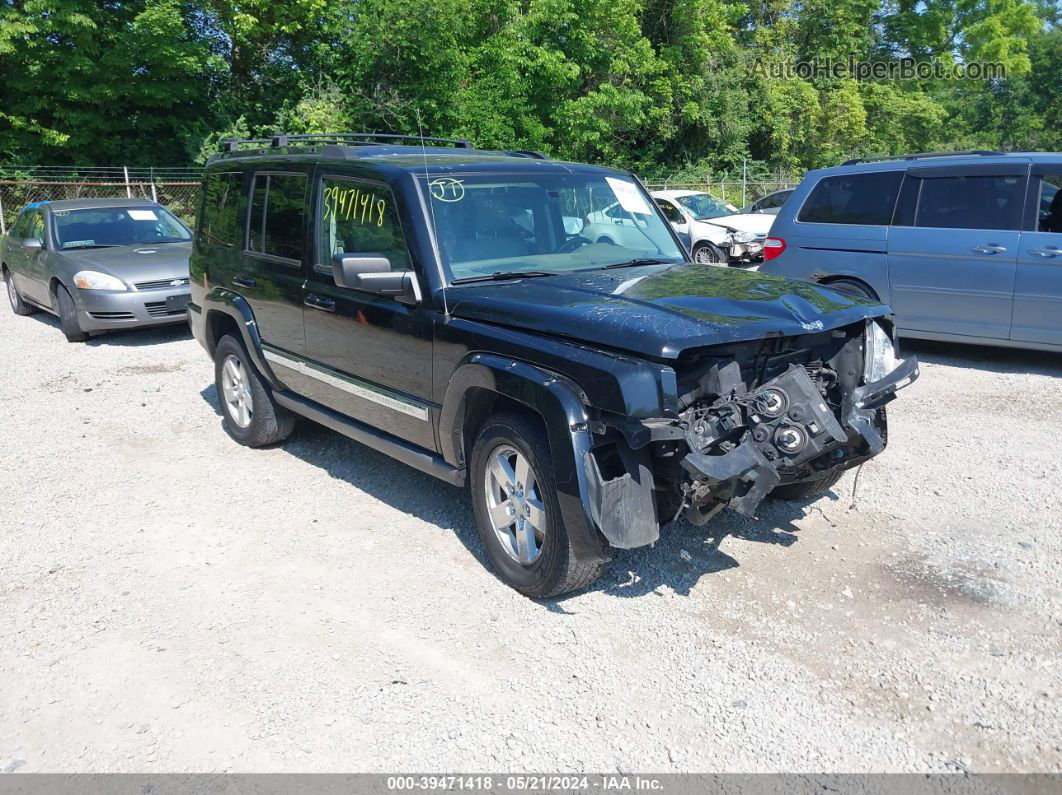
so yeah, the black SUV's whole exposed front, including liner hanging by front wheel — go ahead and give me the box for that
[587,319,918,548]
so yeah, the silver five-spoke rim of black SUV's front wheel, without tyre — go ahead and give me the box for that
[483,445,547,566]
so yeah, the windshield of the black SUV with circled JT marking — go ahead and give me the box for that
[425,174,685,280]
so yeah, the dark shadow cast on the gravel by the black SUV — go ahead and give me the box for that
[200,384,824,602]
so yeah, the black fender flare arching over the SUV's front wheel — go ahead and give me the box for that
[439,353,609,560]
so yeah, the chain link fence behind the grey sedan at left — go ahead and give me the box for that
[0,167,202,234]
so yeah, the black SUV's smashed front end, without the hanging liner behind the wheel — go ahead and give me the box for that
[669,319,919,524]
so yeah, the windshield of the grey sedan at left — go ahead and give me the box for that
[52,205,191,249]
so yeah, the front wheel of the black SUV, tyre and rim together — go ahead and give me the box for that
[469,414,601,598]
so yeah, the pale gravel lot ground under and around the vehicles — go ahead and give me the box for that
[0,307,1062,772]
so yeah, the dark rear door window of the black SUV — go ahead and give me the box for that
[247,174,307,261]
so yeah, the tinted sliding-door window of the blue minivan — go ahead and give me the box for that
[914,174,1025,229]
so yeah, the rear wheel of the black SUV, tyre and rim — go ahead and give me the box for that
[213,334,295,447]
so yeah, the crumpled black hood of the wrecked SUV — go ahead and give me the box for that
[447,264,889,359]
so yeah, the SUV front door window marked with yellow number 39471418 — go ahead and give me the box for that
[318,178,410,271]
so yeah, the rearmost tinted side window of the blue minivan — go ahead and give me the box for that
[797,171,904,226]
